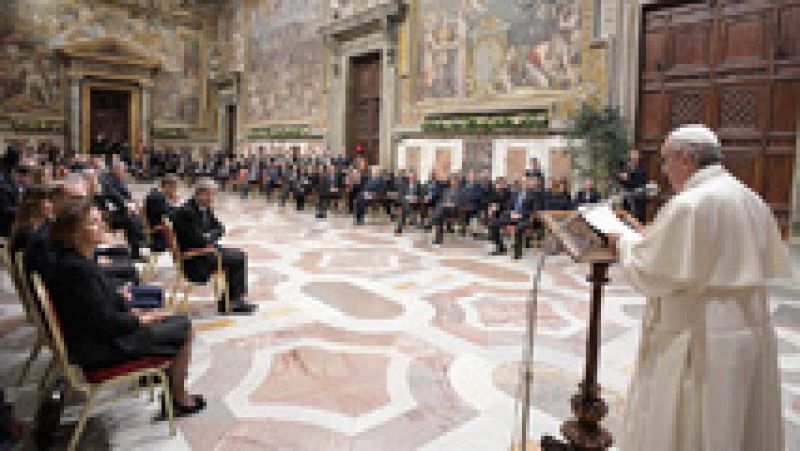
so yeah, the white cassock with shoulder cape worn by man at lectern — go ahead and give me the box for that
[618,165,793,451]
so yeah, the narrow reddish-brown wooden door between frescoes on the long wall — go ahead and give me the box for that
[347,53,381,165]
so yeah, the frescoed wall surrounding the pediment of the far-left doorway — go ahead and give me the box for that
[0,0,203,124]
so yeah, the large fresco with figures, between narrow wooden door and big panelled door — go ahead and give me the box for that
[416,0,581,100]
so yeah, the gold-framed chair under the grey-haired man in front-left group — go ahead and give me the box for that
[159,218,231,314]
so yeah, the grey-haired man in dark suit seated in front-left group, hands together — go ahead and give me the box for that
[175,179,256,314]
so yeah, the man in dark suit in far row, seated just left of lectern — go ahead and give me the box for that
[489,177,544,259]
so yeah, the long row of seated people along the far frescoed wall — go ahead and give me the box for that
[159,158,600,258]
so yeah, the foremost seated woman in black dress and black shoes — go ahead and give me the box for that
[47,200,206,415]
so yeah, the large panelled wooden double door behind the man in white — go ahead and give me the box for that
[636,0,800,237]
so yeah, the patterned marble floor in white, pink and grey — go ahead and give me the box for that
[0,187,800,451]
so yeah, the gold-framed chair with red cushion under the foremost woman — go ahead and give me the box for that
[31,274,175,451]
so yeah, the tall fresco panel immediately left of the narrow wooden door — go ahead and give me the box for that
[246,0,325,122]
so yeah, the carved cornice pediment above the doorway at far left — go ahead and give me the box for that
[55,37,163,70]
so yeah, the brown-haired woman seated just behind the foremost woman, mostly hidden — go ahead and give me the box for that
[9,185,53,261]
